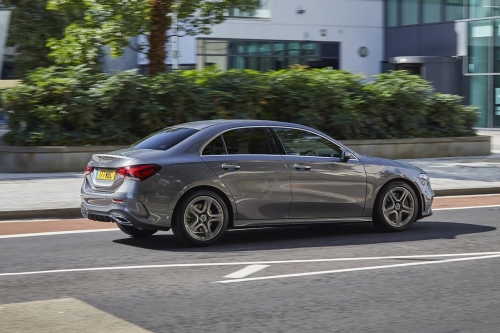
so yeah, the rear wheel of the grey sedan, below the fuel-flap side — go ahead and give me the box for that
[172,190,229,246]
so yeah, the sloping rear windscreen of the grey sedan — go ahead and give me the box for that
[130,127,198,150]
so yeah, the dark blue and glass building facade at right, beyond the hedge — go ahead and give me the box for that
[384,0,500,128]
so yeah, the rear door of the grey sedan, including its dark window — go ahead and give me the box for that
[201,127,291,220]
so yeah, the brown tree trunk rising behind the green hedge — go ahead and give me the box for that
[148,0,172,75]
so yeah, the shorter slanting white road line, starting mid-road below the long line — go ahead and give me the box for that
[215,254,500,283]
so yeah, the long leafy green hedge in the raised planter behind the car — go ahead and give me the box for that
[2,66,477,145]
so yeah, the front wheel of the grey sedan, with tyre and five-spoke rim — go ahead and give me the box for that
[373,181,418,231]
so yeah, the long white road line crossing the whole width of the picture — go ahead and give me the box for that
[0,252,500,276]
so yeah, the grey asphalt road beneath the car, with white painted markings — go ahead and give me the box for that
[0,207,500,332]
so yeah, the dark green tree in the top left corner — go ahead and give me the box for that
[0,0,82,76]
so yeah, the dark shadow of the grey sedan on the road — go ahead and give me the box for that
[114,221,496,252]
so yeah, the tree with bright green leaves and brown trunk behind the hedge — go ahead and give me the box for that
[48,0,260,74]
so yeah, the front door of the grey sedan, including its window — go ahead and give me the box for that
[273,128,366,219]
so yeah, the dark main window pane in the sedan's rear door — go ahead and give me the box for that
[223,128,273,155]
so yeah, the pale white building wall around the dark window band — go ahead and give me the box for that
[189,0,384,75]
